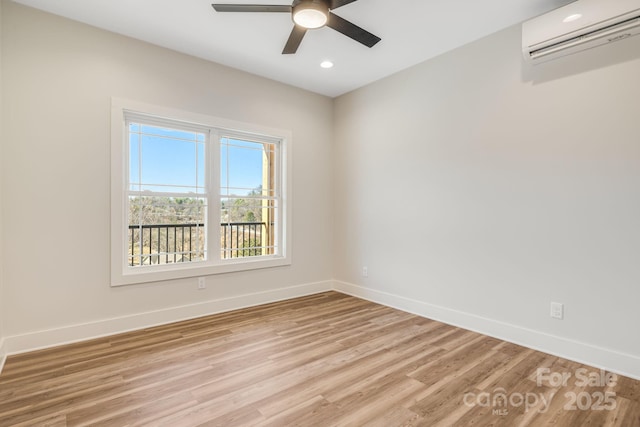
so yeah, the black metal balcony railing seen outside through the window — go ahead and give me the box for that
[128,222,272,266]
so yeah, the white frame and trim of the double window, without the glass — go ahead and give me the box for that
[111,98,292,286]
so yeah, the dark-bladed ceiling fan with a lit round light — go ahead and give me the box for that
[211,0,381,54]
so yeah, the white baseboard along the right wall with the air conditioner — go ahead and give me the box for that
[333,281,640,380]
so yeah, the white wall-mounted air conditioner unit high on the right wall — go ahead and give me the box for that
[522,0,640,64]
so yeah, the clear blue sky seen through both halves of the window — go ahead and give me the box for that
[129,124,262,195]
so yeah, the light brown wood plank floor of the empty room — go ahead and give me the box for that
[0,292,640,427]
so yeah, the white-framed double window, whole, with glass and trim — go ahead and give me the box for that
[111,100,291,285]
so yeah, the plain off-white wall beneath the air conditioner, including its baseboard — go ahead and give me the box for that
[334,27,640,377]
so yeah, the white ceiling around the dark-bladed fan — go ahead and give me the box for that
[14,0,572,97]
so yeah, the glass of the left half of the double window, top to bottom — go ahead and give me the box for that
[127,123,207,266]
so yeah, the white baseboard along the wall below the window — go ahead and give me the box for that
[5,281,333,362]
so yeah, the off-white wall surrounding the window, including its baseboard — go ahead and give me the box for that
[2,1,332,352]
